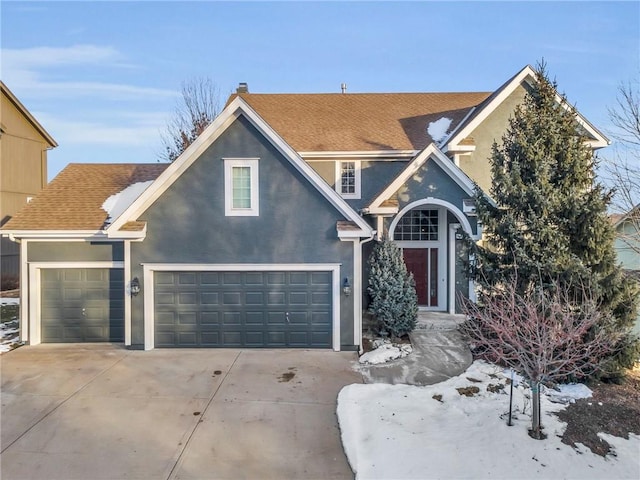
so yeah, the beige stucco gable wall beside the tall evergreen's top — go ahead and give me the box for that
[460,86,525,192]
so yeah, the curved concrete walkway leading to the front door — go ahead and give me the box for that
[360,312,473,386]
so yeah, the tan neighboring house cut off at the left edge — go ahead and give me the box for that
[0,81,58,286]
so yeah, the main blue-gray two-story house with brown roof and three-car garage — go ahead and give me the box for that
[2,66,608,350]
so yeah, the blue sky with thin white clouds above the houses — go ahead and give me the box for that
[1,0,640,178]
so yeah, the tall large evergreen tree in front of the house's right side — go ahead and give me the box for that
[474,64,639,375]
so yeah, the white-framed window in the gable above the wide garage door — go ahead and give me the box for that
[224,158,260,217]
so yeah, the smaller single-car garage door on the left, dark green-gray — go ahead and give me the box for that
[40,268,124,343]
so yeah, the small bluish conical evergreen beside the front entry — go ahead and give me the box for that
[367,238,418,337]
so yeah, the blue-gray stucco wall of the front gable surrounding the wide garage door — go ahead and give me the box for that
[131,116,354,346]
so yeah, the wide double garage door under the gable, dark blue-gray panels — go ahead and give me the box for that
[154,272,332,348]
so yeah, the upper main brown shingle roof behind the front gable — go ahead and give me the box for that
[229,92,491,152]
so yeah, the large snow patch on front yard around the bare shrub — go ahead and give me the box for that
[337,361,640,480]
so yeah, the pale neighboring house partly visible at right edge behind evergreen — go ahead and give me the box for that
[611,205,640,335]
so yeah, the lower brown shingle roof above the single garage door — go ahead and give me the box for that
[2,163,168,231]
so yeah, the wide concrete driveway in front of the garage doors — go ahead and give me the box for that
[0,344,362,480]
